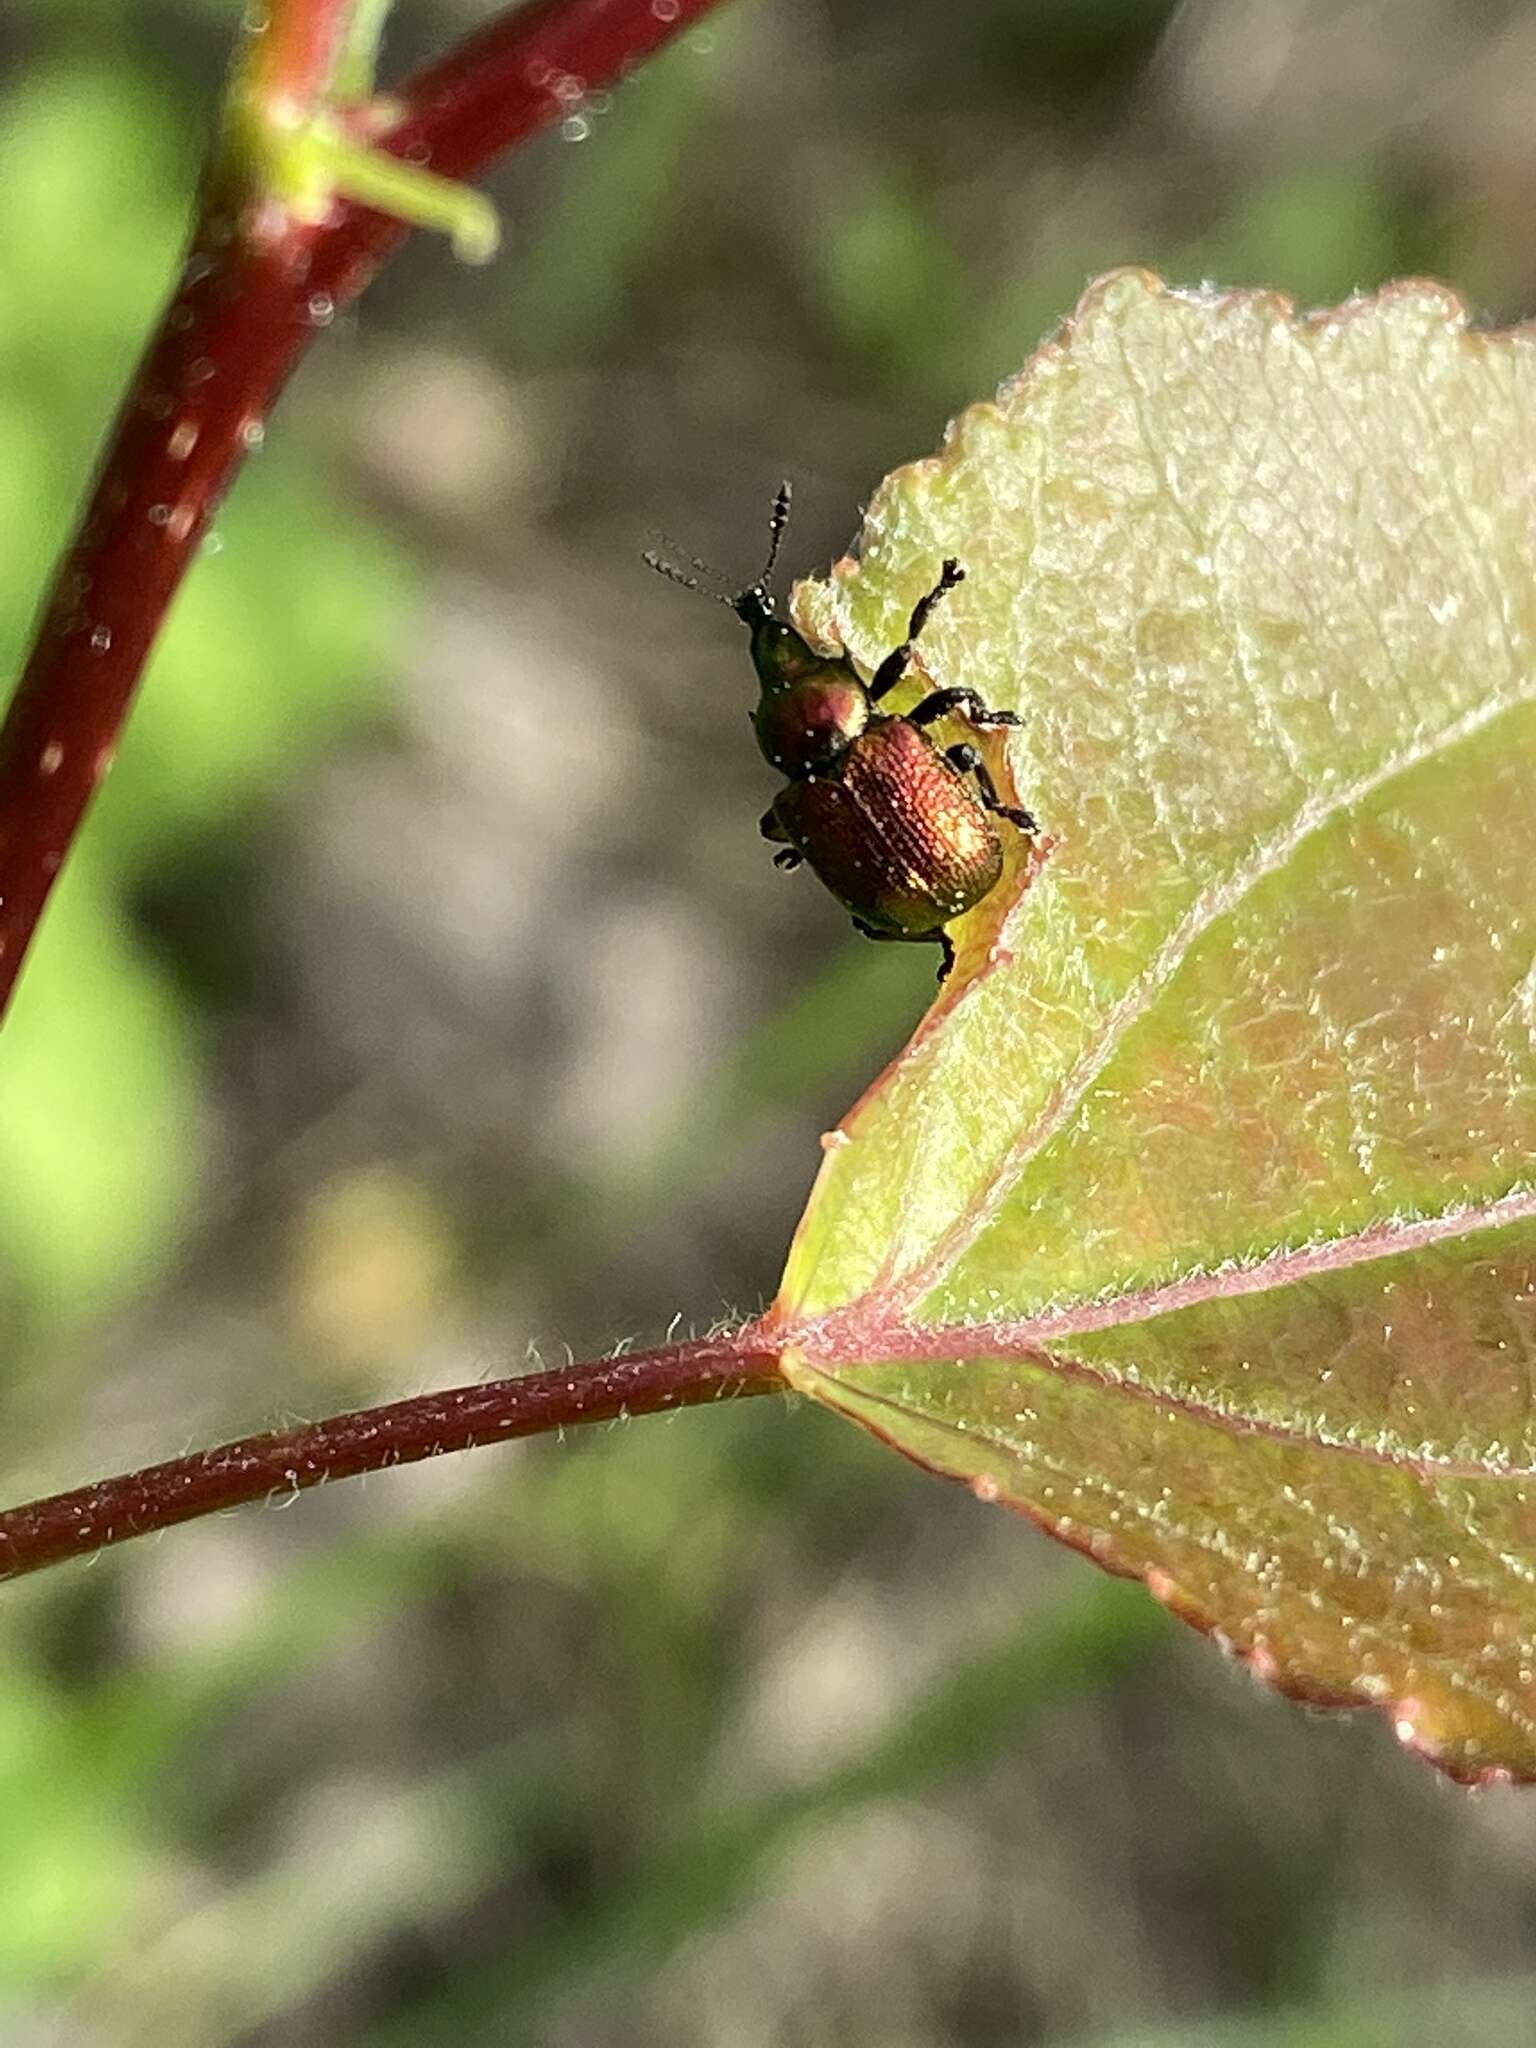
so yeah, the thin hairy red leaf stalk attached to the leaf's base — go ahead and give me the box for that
[0,1329,784,1579]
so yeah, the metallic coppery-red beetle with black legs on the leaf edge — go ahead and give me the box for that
[645,483,1036,981]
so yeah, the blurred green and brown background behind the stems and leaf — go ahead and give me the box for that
[0,0,1536,2048]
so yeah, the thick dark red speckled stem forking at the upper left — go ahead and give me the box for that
[0,0,729,1012]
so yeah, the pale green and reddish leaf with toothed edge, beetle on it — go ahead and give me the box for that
[768,272,1536,1778]
